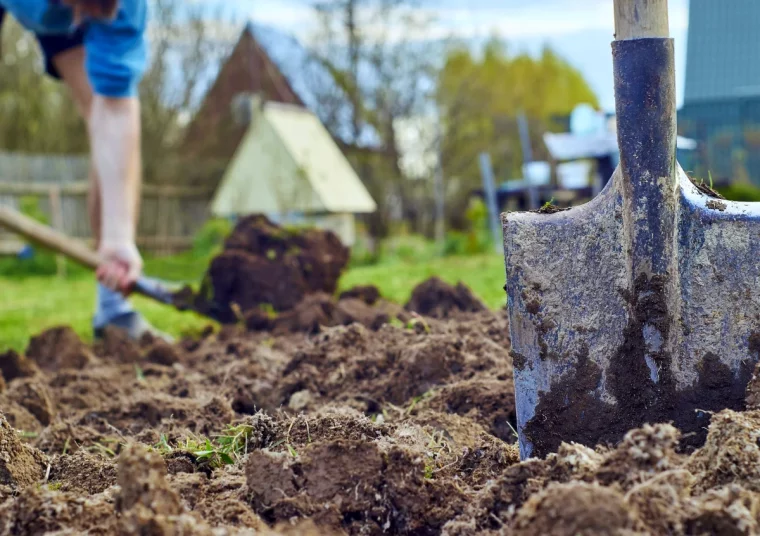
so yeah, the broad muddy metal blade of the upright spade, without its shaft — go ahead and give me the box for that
[503,167,760,458]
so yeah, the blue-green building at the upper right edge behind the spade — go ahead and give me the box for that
[679,0,760,184]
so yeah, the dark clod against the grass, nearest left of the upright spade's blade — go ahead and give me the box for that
[405,277,486,319]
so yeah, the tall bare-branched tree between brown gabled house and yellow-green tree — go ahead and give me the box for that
[302,0,440,247]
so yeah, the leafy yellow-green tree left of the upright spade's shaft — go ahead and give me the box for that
[437,37,598,227]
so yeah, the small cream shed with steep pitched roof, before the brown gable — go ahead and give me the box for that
[211,95,377,246]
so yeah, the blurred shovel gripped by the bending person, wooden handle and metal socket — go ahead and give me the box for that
[0,206,224,321]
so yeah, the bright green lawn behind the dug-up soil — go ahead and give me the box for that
[0,255,505,351]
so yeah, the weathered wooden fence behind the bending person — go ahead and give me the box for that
[0,180,213,255]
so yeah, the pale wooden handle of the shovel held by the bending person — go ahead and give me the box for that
[0,206,100,270]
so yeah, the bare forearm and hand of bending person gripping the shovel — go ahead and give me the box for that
[89,94,142,292]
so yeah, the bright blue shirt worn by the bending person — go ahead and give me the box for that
[0,0,148,97]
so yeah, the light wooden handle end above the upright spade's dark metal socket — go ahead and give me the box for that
[615,0,670,41]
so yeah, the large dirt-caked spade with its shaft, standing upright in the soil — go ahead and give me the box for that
[502,0,760,459]
